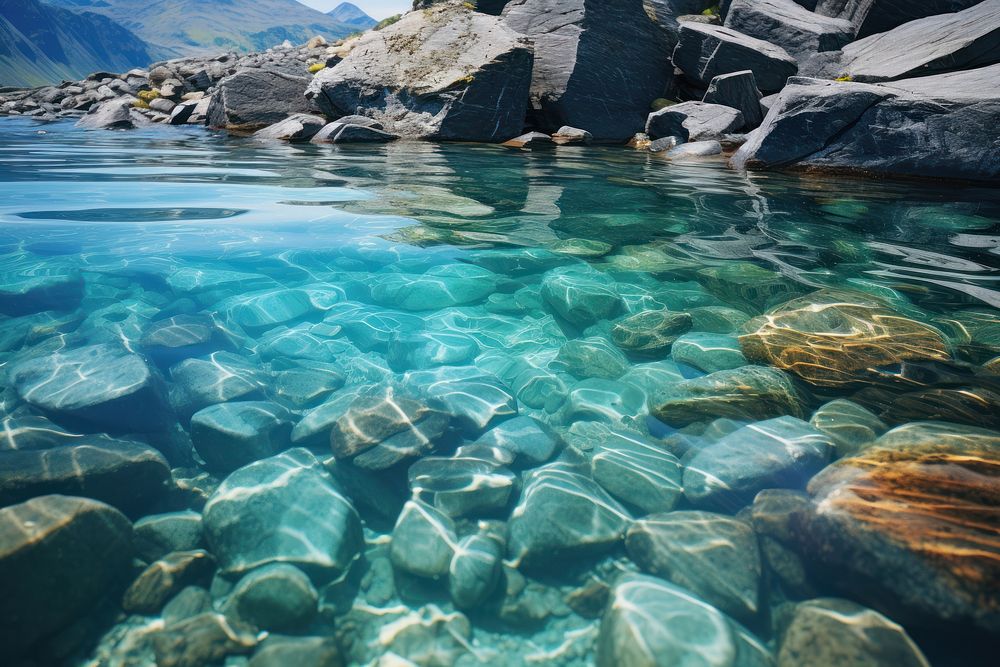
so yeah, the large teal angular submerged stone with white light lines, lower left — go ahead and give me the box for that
[202,449,363,577]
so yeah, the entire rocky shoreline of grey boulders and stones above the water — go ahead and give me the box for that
[0,0,1000,181]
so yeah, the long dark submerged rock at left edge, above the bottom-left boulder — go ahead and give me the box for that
[0,439,170,516]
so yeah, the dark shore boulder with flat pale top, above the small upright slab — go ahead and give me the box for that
[673,23,798,93]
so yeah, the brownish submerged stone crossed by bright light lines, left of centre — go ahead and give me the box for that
[330,387,451,470]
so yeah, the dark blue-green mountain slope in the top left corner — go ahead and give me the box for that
[0,0,157,87]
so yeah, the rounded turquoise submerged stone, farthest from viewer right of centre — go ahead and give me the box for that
[542,267,621,326]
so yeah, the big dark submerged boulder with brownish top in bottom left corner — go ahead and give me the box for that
[0,496,132,662]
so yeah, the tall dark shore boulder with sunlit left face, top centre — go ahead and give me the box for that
[503,0,675,141]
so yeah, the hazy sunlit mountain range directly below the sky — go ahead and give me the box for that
[48,0,357,56]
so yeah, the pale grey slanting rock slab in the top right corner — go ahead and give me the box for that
[828,0,1000,83]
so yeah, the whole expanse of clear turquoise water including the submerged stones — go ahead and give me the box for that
[0,119,1000,667]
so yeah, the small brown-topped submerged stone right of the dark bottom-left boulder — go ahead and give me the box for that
[122,550,215,614]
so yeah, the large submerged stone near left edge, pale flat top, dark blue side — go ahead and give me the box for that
[9,344,164,433]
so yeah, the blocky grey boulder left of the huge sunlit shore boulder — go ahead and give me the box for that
[206,69,309,132]
